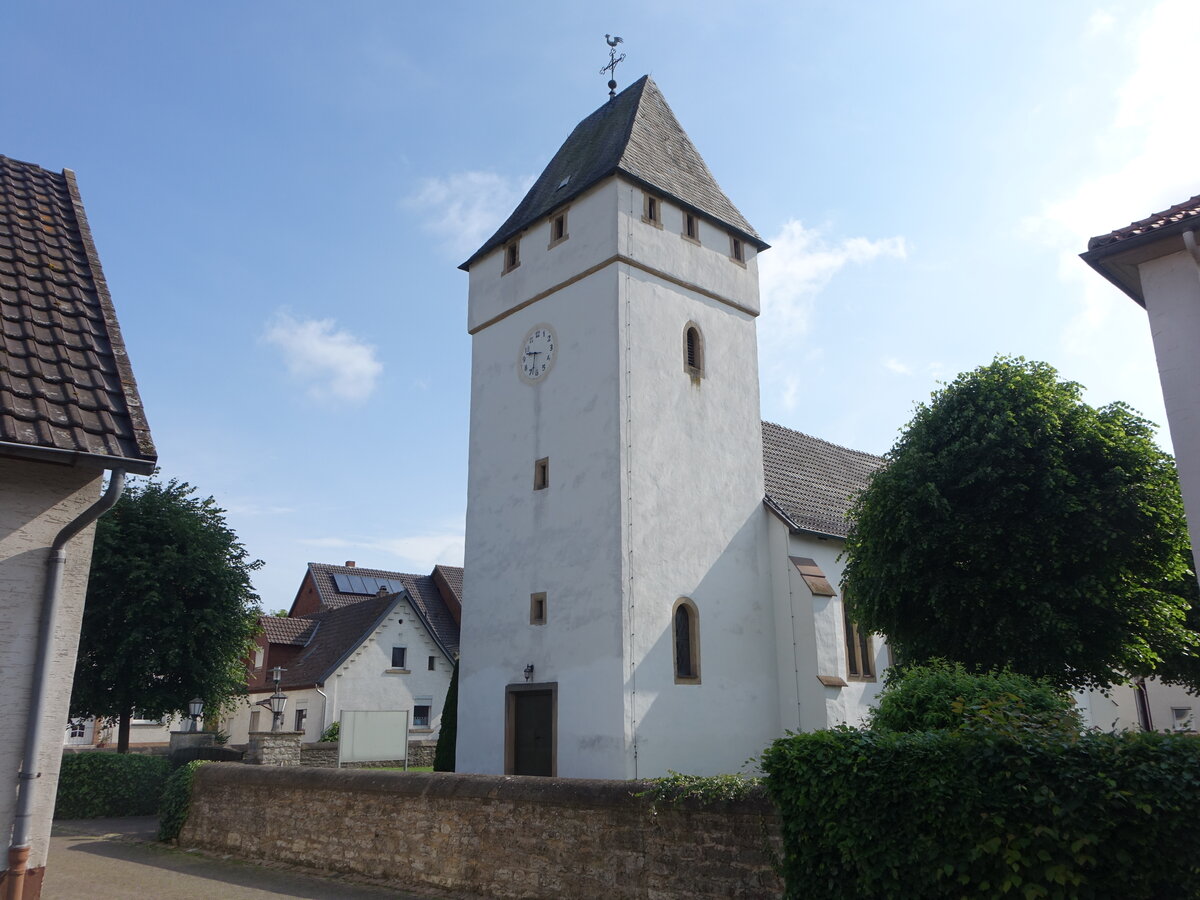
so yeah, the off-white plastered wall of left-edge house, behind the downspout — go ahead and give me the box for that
[0,458,102,883]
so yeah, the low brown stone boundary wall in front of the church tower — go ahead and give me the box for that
[179,763,782,900]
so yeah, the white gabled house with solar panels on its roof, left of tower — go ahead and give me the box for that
[224,562,462,751]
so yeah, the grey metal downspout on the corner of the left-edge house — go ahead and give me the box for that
[5,469,125,900]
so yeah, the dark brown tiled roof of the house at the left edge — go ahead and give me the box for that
[0,156,157,474]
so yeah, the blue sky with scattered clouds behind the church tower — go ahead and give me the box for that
[0,0,1200,610]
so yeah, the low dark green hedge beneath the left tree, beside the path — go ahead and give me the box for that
[54,751,170,818]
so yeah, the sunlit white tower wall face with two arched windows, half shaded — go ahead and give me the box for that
[617,179,780,778]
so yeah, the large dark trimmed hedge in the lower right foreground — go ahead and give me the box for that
[762,727,1200,900]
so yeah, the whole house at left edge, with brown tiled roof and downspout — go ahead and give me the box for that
[0,156,157,900]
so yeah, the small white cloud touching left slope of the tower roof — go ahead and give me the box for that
[408,172,533,257]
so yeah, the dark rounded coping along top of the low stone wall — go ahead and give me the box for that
[187,762,774,815]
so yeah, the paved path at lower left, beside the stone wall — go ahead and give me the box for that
[42,816,432,900]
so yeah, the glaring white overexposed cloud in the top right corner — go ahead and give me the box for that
[1025,0,1200,353]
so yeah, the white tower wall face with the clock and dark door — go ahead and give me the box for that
[457,180,625,778]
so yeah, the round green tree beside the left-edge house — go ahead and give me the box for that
[71,479,263,752]
